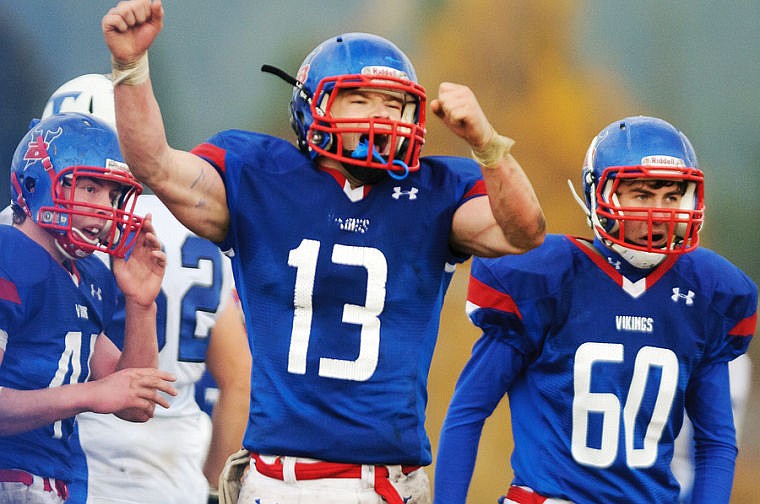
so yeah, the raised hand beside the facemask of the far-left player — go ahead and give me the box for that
[112,214,166,306]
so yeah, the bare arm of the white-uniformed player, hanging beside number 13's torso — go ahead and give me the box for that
[203,299,251,488]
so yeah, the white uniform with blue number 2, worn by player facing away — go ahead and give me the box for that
[78,195,233,504]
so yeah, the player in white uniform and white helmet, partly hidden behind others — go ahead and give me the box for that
[36,74,250,504]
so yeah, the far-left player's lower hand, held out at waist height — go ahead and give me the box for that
[89,368,177,422]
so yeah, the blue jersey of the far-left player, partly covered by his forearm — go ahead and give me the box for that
[0,225,117,482]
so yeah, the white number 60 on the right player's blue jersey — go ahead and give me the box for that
[570,343,678,468]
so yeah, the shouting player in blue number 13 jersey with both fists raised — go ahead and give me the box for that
[102,0,544,504]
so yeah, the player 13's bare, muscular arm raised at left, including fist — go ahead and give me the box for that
[102,0,229,241]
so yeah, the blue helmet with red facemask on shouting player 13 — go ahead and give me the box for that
[290,33,426,177]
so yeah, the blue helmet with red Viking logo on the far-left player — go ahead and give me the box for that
[11,112,143,259]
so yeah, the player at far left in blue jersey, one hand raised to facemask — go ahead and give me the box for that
[0,113,175,503]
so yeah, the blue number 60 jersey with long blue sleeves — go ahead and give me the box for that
[436,235,757,504]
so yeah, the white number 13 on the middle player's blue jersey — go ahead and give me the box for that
[288,239,388,381]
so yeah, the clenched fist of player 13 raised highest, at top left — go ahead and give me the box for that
[101,0,164,63]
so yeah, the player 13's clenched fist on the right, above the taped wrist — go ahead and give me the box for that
[430,82,494,149]
